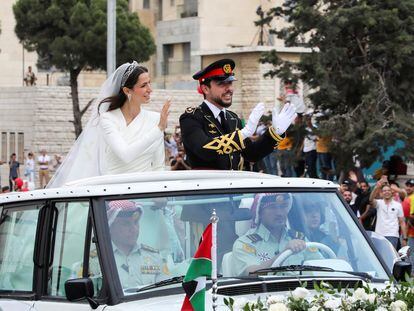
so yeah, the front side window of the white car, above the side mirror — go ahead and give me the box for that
[47,201,89,296]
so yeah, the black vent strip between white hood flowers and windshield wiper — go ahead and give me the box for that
[217,280,362,296]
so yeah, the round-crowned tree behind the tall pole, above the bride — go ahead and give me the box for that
[13,0,155,137]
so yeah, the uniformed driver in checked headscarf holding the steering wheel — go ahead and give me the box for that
[232,193,321,275]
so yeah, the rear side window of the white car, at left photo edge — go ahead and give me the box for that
[0,204,42,291]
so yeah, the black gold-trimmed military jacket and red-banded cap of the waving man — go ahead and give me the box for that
[180,59,283,170]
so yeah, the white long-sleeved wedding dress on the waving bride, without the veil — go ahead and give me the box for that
[99,109,165,175]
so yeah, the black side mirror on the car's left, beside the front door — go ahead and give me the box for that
[65,278,99,309]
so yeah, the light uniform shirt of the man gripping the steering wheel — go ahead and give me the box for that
[232,225,322,275]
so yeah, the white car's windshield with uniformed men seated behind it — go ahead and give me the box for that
[105,192,388,293]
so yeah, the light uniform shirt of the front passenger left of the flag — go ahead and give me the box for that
[112,244,165,289]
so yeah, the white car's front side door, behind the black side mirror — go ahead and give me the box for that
[34,199,105,311]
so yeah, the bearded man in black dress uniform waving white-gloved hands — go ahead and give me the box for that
[180,59,295,170]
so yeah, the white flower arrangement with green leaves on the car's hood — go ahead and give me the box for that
[224,280,414,311]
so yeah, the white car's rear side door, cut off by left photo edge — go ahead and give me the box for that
[0,202,45,311]
